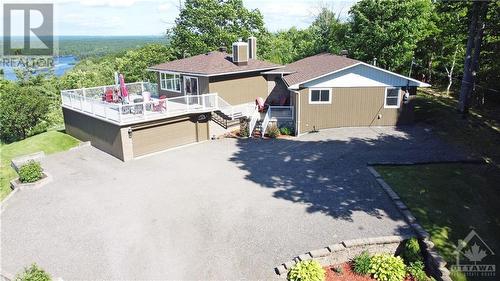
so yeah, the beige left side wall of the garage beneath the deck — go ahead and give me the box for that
[63,108,128,161]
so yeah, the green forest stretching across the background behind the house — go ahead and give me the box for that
[0,0,500,143]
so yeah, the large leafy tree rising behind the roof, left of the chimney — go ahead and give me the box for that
[167,0,266,57]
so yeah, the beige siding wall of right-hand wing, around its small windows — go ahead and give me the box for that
[299,87,413,133]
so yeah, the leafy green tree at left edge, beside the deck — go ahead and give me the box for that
[0,82,51,142]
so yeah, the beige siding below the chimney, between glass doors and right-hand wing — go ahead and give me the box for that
[209,73,268,105]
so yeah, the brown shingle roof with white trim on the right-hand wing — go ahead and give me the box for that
[279,53,430,88]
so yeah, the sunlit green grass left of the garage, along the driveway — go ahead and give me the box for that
[0,131,79,200]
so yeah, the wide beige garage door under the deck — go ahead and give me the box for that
[132,116,196,157]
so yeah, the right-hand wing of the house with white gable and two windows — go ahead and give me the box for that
[275,53,430,134]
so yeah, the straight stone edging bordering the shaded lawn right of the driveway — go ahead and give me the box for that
[367,164,454,281]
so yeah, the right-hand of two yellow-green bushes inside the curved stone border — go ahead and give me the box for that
[370,254,406,281]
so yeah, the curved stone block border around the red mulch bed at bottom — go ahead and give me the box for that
[274,235,413,277]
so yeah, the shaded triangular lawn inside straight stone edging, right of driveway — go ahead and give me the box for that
[376,164,500,263]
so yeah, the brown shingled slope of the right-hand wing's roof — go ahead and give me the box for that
[280,53,360,86]
